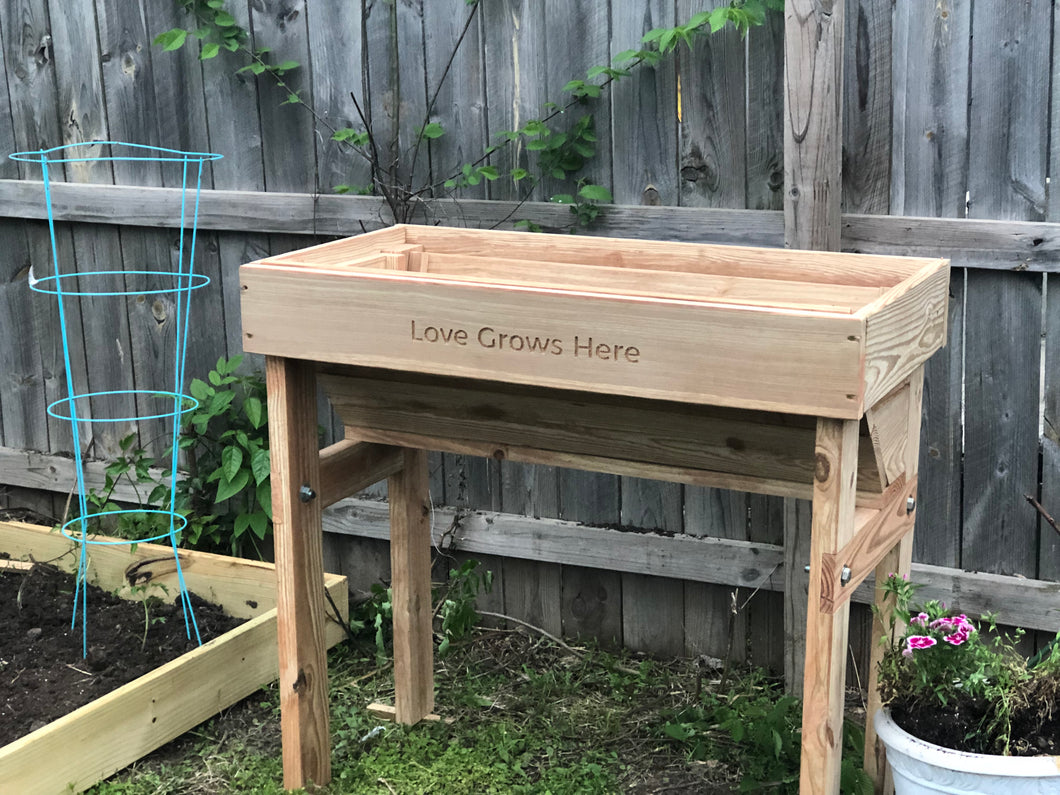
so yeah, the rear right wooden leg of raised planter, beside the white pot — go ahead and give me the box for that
[864,367,923,795]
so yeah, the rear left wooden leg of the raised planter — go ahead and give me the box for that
[387,448,435,724]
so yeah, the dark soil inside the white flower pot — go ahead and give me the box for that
[889,695,1060,756]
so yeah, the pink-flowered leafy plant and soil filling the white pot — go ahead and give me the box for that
[879,575,1060,756]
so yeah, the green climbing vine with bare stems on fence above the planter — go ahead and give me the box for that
[155,0,783,231]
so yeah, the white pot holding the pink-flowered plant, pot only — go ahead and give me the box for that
[875,709,1060,795]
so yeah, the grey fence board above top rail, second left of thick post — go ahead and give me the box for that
[677,0,747,207]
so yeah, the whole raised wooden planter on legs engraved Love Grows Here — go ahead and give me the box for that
[241,226,949,795]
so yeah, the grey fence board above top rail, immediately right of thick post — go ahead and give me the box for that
[842,0,894,213]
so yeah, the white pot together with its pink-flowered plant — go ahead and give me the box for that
[875,576,1060,795]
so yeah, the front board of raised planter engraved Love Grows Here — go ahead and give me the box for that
[241,266,863,417]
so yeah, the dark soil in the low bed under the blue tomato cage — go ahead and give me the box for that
[0,564,243,747]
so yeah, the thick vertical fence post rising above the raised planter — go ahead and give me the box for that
[784,0,845,251]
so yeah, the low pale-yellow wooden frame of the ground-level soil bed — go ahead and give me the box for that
[0,523,348,795]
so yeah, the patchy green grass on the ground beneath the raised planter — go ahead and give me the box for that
[90,630,871,795]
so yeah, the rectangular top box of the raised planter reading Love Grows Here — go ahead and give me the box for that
[241,226,949,419]
